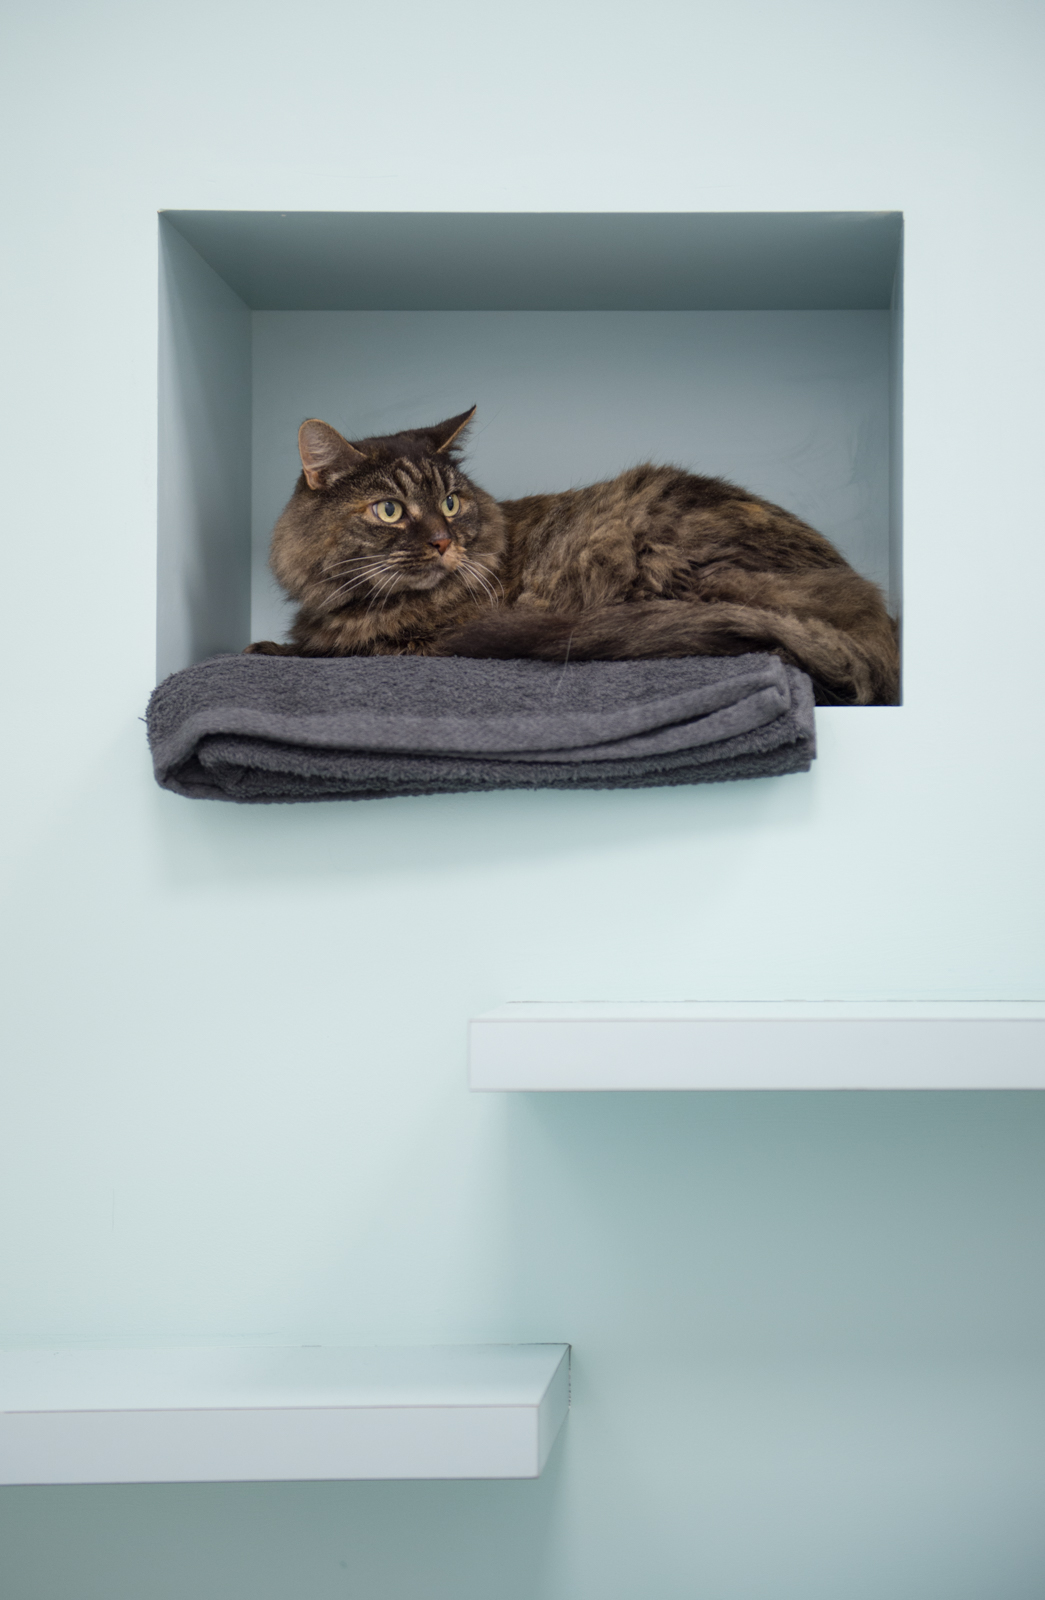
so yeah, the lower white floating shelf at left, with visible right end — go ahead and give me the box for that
[0,1344,570,1483]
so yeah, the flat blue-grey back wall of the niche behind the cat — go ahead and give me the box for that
[251,310,891,638]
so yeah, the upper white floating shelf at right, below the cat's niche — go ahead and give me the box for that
[469,1000,1045,1090]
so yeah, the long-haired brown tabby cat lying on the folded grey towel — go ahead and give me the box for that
[248,408,899,706]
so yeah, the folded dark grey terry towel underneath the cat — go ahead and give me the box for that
[146,654,816,802]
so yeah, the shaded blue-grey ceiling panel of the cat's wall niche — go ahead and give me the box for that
[162,211,903,310]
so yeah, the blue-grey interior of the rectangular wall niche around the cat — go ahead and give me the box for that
[157,211,903,677]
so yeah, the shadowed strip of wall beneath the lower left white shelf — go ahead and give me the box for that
[0,1430,565,1600]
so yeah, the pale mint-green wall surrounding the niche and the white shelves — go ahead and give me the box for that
[0,0,1045,1600]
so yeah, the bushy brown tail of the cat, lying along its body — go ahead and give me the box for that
[435,600,899,706]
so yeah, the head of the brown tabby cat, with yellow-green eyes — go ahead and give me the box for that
[272,406,499,610]
